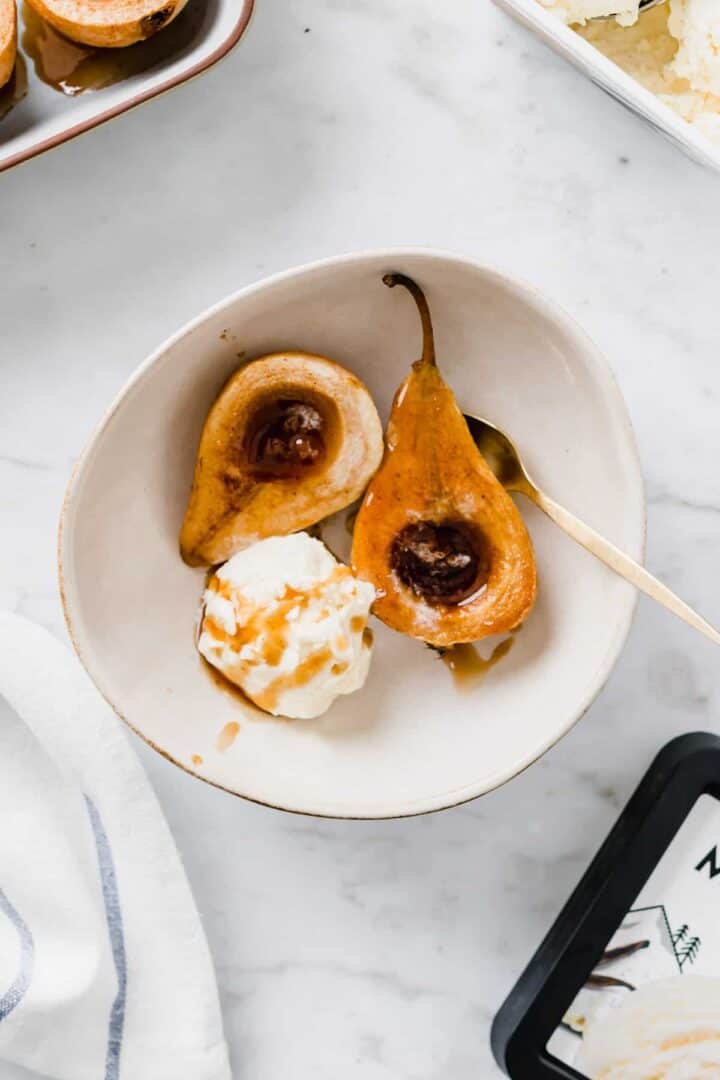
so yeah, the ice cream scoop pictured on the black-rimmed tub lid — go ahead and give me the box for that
[575,975,720,1080]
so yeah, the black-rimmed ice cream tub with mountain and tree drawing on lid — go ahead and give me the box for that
[491,733,720,1080]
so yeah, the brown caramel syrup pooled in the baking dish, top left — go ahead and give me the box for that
[22,0,206,95]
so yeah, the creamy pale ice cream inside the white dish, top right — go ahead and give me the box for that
[539,0,720,143]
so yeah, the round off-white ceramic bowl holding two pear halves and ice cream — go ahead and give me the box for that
[59,251,644,818]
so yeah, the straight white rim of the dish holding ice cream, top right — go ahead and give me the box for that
[494,0,720,171]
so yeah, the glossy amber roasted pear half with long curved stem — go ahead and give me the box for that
[352,274,536,647]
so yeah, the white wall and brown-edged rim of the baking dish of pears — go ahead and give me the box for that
[0,0,254,172]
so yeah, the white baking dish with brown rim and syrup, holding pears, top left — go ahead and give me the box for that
[0,0,254,172]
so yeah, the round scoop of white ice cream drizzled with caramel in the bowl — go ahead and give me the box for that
[198,532,375,718]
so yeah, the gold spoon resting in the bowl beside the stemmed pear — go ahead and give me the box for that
[465,414,720,645]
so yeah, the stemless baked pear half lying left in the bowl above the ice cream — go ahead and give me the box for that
[180,352,383,566]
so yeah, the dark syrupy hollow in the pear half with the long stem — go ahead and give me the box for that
[390,522,490,605]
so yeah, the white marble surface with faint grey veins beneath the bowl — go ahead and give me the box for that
[0,0,720,1080]
